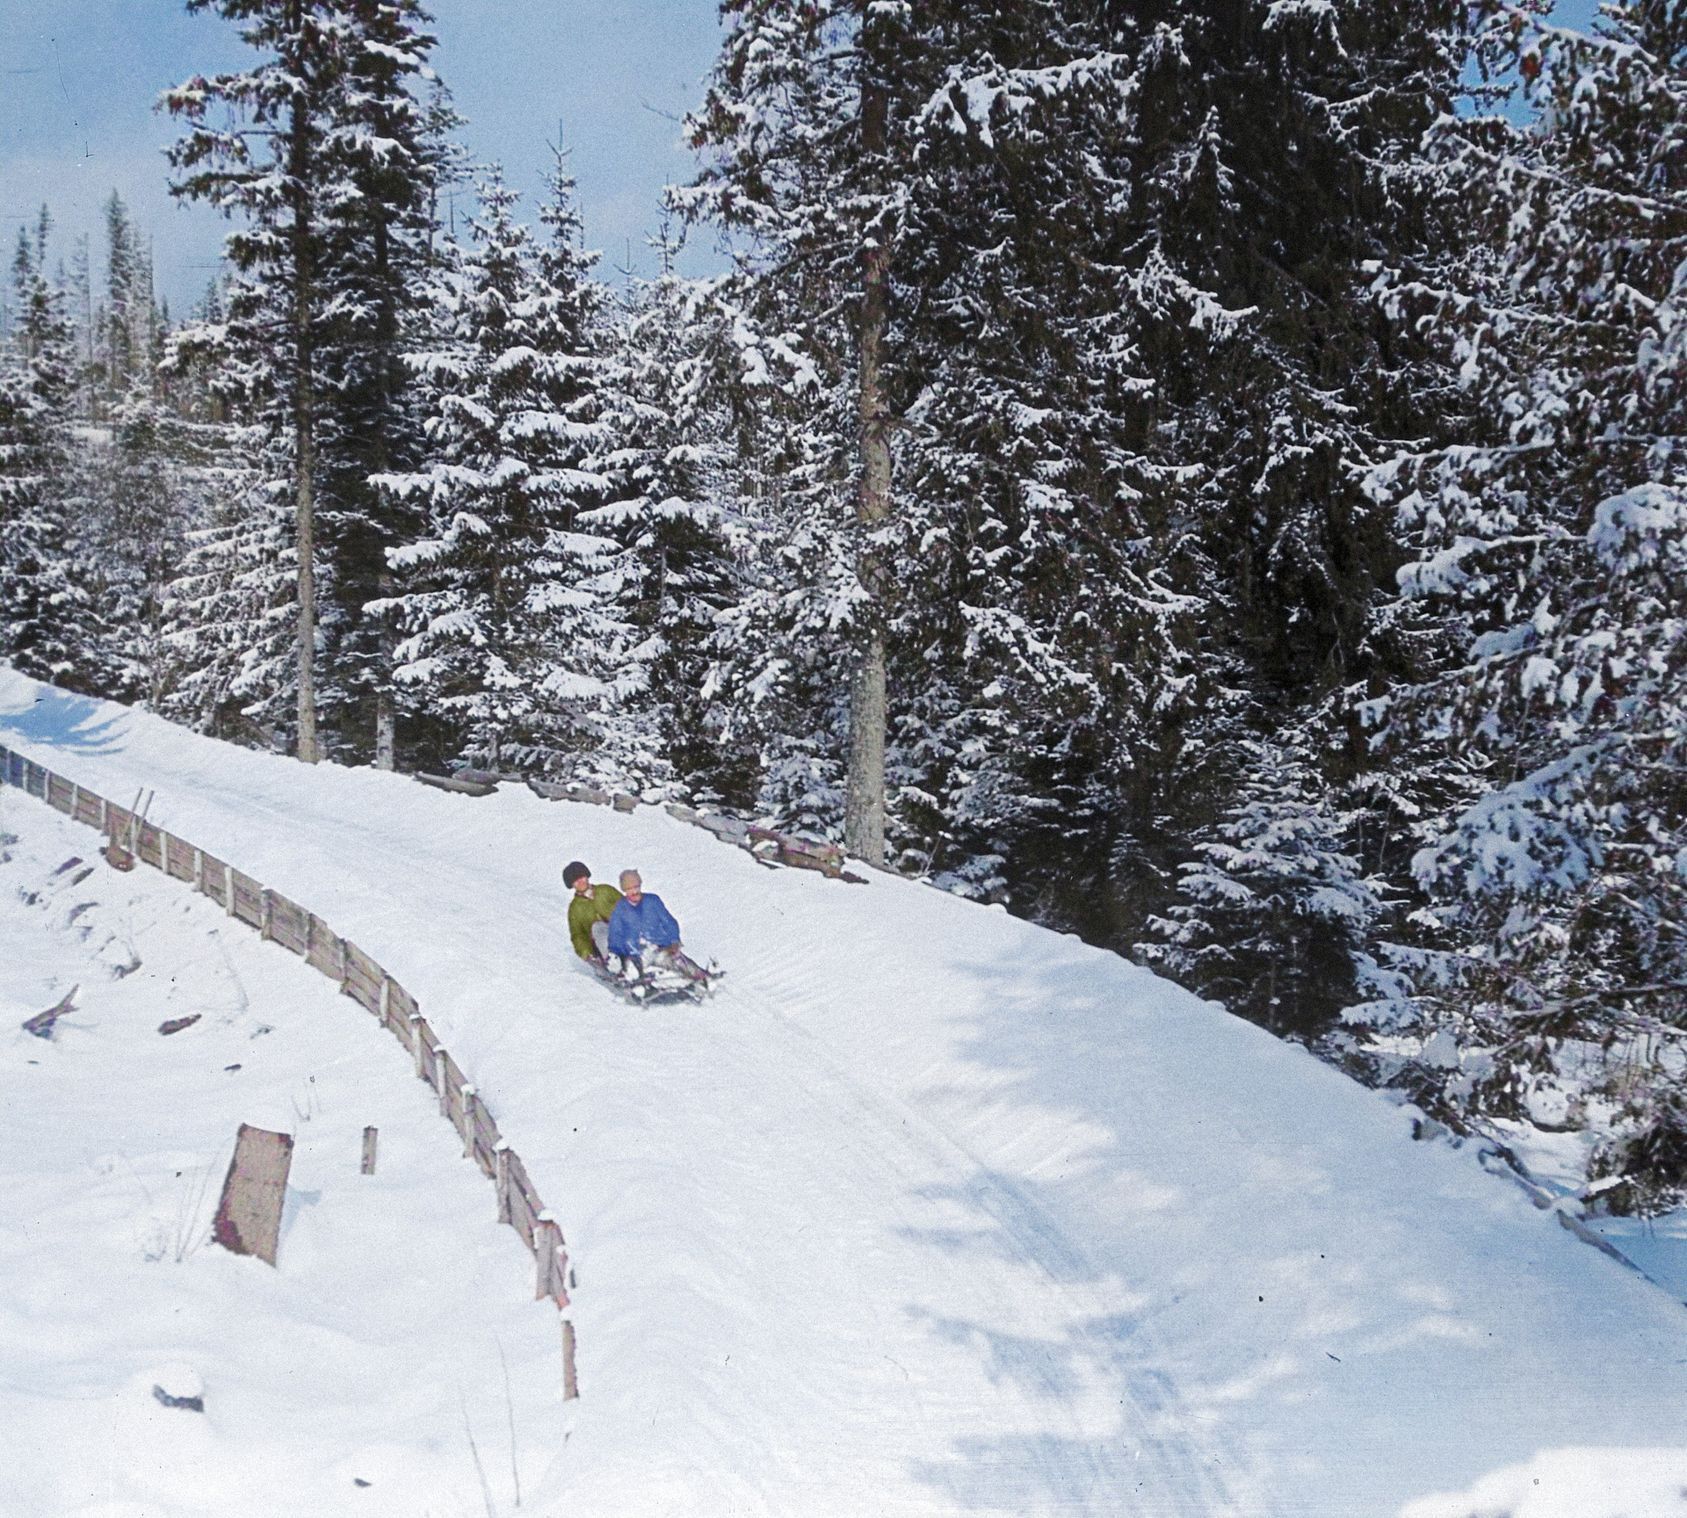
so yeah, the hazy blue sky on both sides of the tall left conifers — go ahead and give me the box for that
[0,0,720,309]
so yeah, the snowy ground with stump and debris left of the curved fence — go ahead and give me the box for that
[0,772,565,1518]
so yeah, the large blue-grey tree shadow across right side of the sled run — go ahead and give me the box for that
[903,933,1682,1518]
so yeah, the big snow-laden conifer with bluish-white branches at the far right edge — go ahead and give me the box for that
[1366,0,1687,1209]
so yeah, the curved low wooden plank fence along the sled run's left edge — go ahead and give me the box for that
[0,744,579,1397]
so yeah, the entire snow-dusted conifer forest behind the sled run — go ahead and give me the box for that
[0,0,1687,1214]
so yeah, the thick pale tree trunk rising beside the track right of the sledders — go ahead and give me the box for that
[844,62,891,869]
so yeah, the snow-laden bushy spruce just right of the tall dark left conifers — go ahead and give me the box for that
[378,170,633,772]
